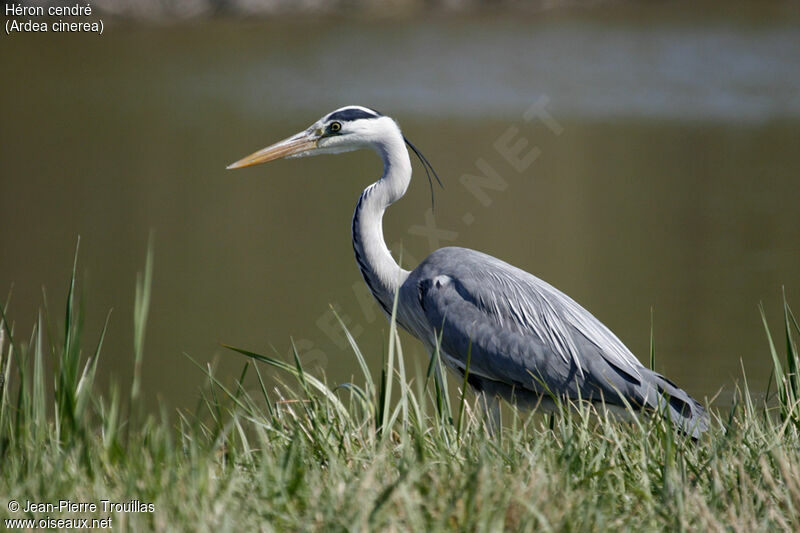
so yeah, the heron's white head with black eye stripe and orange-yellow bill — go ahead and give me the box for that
[228,106,396,169]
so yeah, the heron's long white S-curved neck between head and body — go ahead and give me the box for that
[353,134,411,314]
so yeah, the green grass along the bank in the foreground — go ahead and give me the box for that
[0,249,800,531]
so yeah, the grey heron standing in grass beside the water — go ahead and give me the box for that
[228,106,708,438]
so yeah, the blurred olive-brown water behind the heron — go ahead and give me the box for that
[0,2,800,406]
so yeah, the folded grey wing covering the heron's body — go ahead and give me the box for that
[412,248,643,399]
